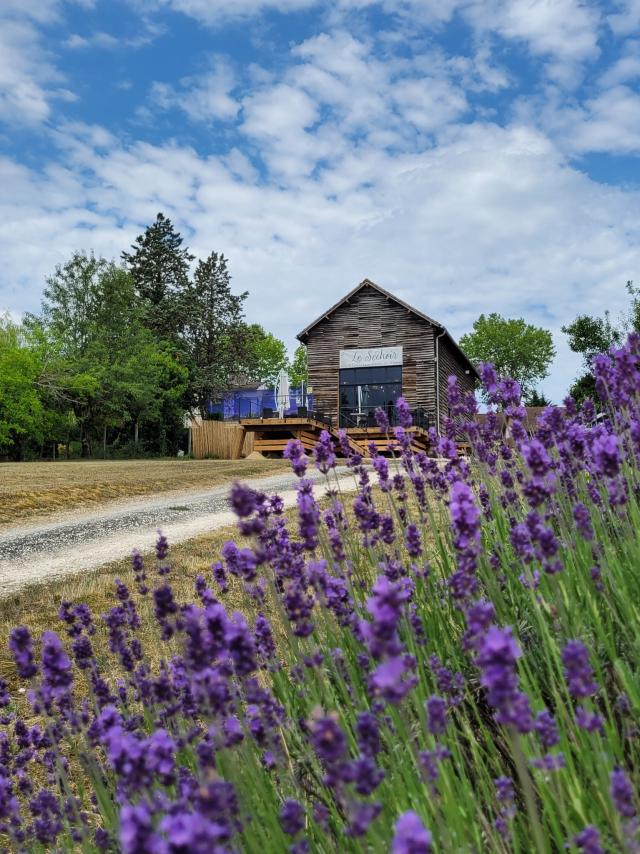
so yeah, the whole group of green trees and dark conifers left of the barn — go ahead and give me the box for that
[0,213,301,459]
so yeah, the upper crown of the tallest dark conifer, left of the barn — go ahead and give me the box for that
[122,213,194,342]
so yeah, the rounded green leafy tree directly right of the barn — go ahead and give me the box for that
[460,312,556,397]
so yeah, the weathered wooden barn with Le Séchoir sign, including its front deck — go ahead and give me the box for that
[241,279,477,452]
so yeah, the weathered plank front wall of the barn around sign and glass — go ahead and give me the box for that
[307,286,436,423]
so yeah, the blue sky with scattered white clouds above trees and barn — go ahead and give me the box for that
[0,0,640,400]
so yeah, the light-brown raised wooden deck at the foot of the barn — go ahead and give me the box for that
[239,416,430,457]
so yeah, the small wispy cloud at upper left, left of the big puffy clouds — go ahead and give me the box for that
[150,57,240,122]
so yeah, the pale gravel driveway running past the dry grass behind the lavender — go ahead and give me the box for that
[0,468,355,596]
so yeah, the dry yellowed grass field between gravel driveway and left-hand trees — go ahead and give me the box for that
[0,460,289,526]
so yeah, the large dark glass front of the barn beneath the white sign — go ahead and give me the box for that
[340,365,402,427]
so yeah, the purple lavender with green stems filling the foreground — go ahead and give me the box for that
[0,335,640,854]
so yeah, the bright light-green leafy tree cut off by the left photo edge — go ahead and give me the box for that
[0,314,44,458]
